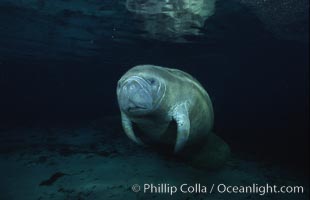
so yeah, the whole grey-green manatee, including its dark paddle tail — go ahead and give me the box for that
[117,65,230,168]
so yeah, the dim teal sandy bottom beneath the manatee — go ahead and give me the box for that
[0,119,309,200]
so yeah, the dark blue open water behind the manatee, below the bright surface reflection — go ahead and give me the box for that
[0,1,309,171]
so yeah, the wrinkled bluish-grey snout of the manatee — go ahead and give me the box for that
[118,77,153,113]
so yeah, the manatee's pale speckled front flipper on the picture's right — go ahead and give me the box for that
[172,103,190,153]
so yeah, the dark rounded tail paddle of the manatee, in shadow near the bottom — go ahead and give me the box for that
[189,132,230,169]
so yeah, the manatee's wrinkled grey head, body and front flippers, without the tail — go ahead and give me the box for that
[117,65,213,153]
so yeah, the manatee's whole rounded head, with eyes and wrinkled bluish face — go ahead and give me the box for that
[117,68,166,115]
